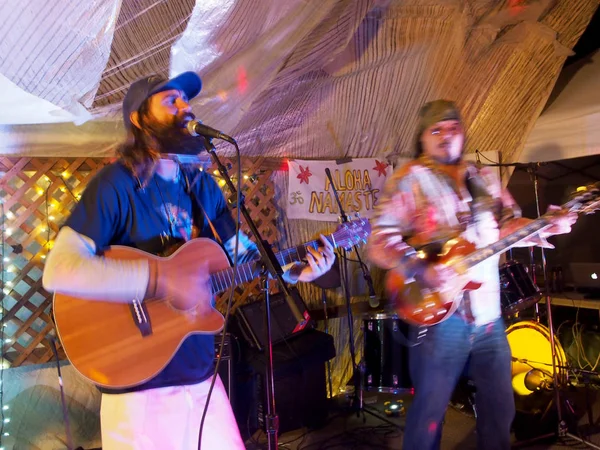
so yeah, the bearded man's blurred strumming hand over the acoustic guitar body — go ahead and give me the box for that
[146,253,212,315]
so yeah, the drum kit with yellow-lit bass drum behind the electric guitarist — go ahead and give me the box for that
[362,261,568,397]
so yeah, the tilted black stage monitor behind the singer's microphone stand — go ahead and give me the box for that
[235,286,314,351]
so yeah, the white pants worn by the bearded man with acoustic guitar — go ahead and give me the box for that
[100,377,245,450]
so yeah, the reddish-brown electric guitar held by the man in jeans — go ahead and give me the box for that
[385,183,600,325]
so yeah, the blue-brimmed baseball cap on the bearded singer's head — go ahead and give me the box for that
[123,72,202,130]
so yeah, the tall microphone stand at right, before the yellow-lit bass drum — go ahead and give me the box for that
[483,157,600,450]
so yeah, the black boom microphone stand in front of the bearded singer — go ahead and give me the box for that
[203,137,306,450]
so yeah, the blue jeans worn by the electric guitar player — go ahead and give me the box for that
[402,314,515,450]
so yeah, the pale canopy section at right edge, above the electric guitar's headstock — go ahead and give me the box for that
[519,51,600,162]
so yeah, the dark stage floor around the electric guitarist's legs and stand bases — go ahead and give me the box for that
[246,387,600,450]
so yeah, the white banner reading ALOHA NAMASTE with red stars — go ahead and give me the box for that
[287,158,393,222]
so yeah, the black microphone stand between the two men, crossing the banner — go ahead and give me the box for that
[325,168,398,427]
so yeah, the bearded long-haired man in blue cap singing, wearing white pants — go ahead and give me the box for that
[43,72,334,450]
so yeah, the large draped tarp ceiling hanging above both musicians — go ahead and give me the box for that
[0,0,592,160]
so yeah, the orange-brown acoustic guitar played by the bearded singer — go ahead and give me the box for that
[53,219,371,388]
